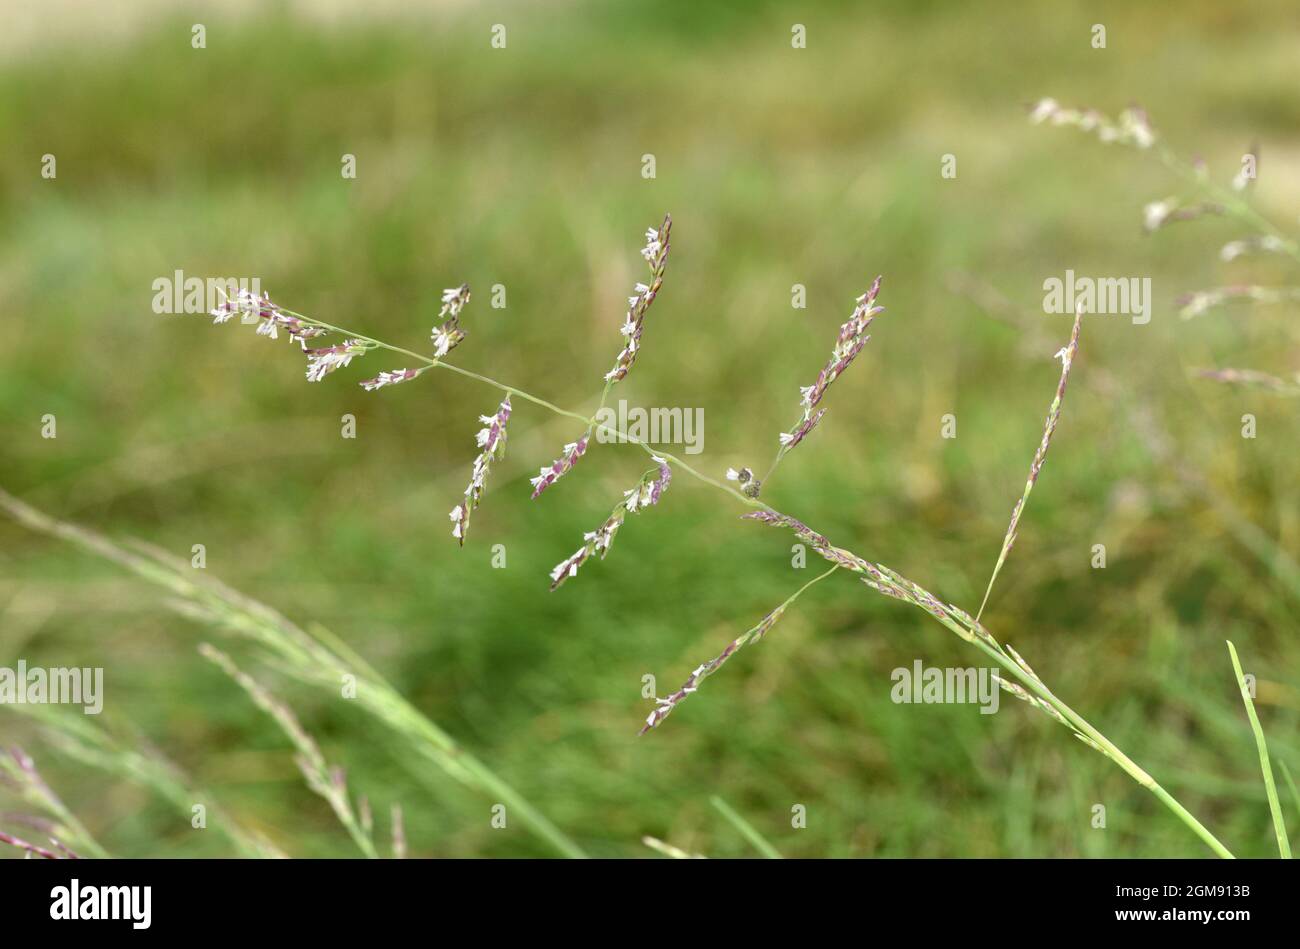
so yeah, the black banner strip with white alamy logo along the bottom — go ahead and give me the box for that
[0,859,1296,939]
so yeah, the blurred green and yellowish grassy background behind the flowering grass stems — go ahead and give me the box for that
[0,0,1300,857]
